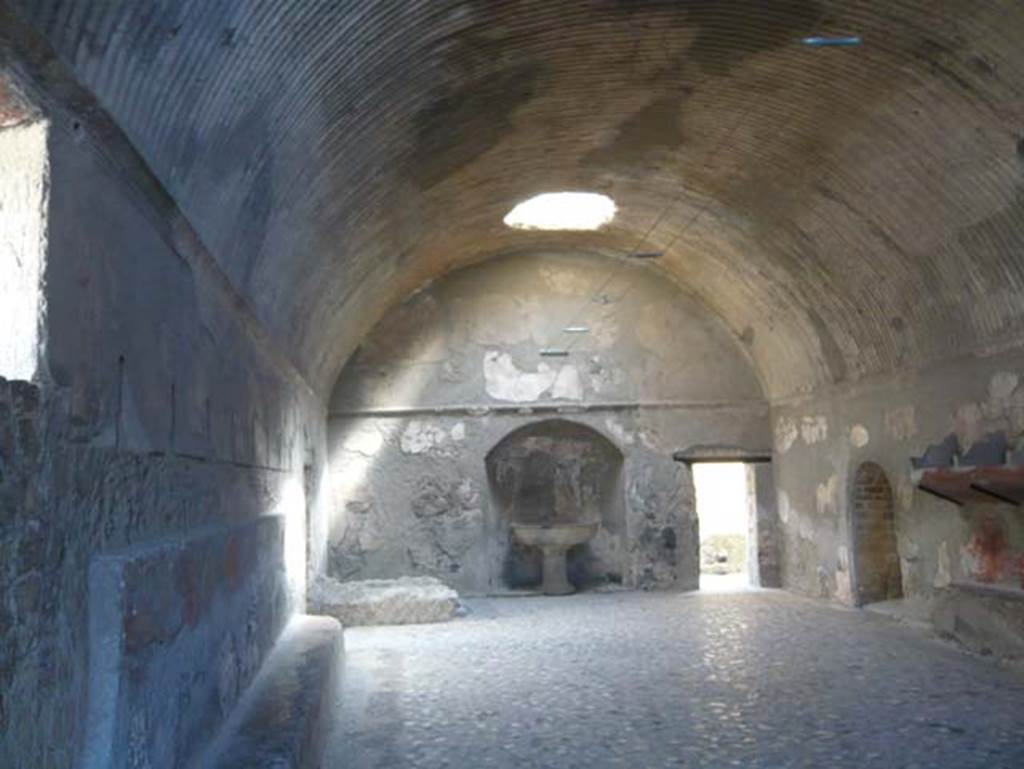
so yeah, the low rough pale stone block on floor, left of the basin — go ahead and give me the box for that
[310,576,461,627]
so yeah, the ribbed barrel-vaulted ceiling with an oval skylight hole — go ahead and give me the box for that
[10,0,1024,397]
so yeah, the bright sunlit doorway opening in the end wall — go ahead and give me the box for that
[692,462,753,592]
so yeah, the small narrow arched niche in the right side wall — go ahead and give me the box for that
[850,462,903,605]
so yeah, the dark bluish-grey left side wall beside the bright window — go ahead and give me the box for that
[0,57,326,769]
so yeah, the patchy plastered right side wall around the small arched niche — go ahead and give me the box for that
[772,351,1024,603]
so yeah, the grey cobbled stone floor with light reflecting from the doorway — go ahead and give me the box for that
[326,591,1024,769]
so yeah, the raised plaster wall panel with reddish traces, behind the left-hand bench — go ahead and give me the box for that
[85,516,290,769]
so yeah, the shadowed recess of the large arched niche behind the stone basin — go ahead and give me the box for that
[486,419,626,589]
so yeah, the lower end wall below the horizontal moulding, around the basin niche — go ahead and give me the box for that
[329,409,765,594]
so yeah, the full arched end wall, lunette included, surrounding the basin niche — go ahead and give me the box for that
[329,253,769,593]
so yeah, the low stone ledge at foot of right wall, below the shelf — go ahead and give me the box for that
[932,585,1024,660]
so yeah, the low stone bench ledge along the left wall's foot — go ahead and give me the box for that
[201,615,343,769]
